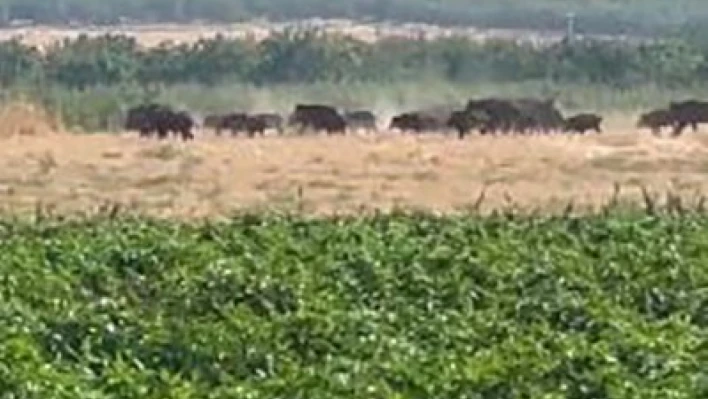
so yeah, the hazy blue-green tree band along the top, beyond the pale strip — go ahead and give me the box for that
[0,0,708,35]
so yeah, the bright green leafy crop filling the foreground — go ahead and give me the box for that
[0,214,708,399]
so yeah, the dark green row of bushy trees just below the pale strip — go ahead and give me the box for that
[0,32,708,89]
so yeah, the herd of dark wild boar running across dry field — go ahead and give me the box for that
[125,98,708,140]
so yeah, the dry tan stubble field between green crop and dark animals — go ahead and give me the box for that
[0,107,708,218]
